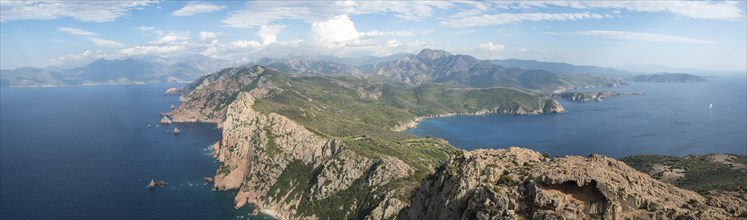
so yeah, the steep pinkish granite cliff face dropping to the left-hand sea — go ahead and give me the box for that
[214,92,413,219]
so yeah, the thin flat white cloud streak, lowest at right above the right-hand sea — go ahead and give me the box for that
[560,30,713,44]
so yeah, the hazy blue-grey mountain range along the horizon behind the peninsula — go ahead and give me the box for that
[0,49,632,91]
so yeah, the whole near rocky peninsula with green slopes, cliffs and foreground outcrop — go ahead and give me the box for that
[168,66,747,219]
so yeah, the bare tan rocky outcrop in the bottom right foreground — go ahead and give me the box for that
[399,147,741,219]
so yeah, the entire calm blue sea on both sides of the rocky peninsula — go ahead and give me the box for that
[0,77,747,219]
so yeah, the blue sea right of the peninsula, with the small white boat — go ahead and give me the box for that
[407,73,747,157]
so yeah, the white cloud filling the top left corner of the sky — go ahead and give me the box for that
[0,0,155,22]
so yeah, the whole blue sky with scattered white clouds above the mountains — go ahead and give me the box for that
[0,1,747,70]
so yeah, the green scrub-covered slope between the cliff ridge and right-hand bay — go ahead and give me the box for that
[254,71,552,140]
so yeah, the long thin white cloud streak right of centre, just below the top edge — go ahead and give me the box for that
[441,12,605,28]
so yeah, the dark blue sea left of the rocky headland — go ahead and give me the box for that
[0,84,266,219]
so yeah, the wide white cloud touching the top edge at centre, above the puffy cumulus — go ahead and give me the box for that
[222,1,453,28]
